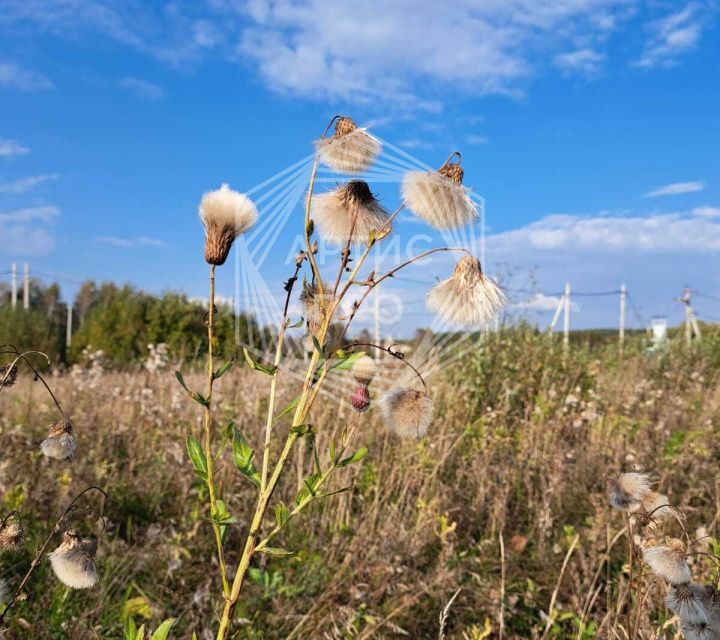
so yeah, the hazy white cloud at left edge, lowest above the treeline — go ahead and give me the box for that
[0,205,60,255]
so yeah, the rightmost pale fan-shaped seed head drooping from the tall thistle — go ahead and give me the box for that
[427,256,507,326]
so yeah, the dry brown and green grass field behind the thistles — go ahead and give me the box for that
[0,329,720,640]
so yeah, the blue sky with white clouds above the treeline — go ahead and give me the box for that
[0,0,720,333]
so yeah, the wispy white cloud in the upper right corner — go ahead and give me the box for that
[635,2,705,67]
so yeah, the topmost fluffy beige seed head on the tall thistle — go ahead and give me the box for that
[315,117,382,173]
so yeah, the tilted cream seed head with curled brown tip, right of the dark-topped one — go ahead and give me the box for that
[402,153,478,229]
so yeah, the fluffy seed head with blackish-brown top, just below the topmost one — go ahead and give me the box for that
[312,180,388,245]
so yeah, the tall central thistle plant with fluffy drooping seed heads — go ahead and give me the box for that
[177,116,505,640]
